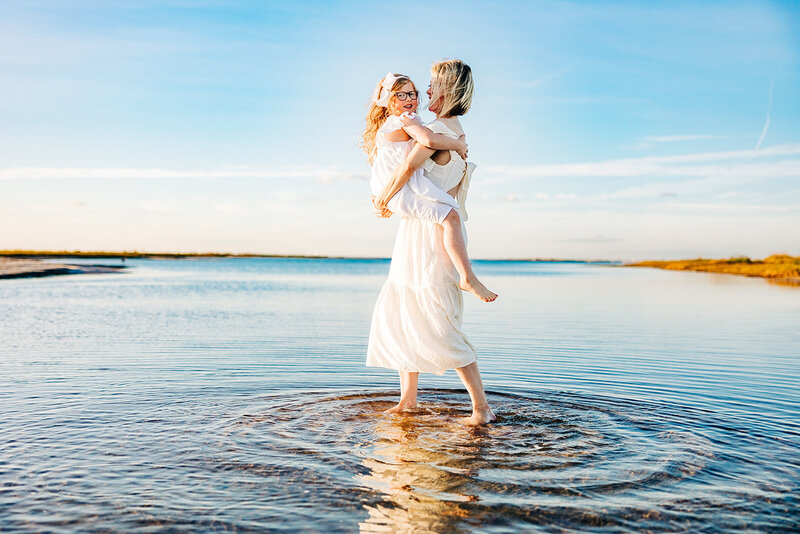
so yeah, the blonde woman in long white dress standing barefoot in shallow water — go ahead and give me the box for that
[367,60,496,425]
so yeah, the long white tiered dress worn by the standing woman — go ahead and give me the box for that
[367,121,477,375]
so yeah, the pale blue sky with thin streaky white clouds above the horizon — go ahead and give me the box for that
[0,0,800,259]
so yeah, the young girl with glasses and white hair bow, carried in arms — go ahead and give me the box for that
[363,73,497,302]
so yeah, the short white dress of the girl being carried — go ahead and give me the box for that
[369,115,458,224]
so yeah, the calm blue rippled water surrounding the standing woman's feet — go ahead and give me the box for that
[0,259,800,532]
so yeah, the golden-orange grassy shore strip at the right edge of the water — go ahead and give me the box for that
[626,254,800,279]
